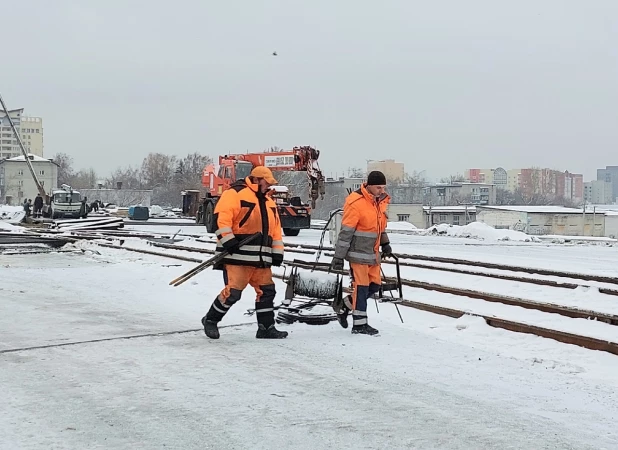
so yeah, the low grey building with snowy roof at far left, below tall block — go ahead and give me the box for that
[0,155,58,205]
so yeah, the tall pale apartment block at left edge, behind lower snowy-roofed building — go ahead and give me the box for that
[0,108,43,160]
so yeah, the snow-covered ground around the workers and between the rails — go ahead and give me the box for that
[0,224,618,449]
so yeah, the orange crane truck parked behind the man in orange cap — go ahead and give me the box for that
[196,146,325,236]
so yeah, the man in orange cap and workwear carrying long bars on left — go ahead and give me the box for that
[202,166,288,339]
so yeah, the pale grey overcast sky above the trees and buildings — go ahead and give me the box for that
[0,0,618,179]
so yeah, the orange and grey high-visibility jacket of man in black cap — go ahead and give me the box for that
[335,185,390,266]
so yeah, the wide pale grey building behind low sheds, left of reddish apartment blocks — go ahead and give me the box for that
[423,182,496,206]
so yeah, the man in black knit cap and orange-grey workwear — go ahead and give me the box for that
[331,171,392,335]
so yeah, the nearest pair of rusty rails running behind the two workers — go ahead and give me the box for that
[85,242,618,355]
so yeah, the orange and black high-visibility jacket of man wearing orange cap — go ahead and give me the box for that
[214,178,283,268]
